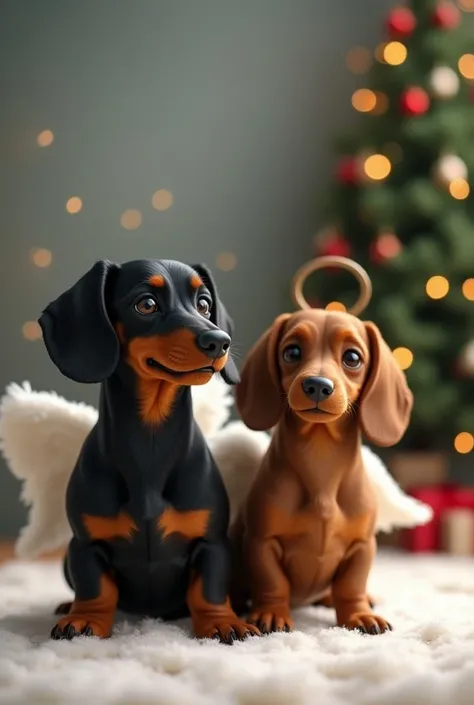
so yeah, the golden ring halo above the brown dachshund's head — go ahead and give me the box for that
[292,255,372,316]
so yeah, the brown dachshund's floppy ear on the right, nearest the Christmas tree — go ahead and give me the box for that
[359,322,413,446]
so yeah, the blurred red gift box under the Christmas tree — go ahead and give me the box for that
[400,485,474,553]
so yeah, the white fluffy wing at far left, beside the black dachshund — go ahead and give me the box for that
[0,382,97,559]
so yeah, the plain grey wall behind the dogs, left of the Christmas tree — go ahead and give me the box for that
[0,0,393,536]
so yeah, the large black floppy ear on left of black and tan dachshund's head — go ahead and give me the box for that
[39,261,120,384]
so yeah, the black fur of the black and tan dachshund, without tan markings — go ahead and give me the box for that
[39,260,243,638]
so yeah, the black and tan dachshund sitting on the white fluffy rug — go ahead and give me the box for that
[39,260,259,643]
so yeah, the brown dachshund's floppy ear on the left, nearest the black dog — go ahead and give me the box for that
[237,313,291,431]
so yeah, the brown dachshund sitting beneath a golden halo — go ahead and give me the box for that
[232,309,413,634]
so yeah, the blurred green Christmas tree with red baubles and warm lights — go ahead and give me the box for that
[312,0,474,453]
